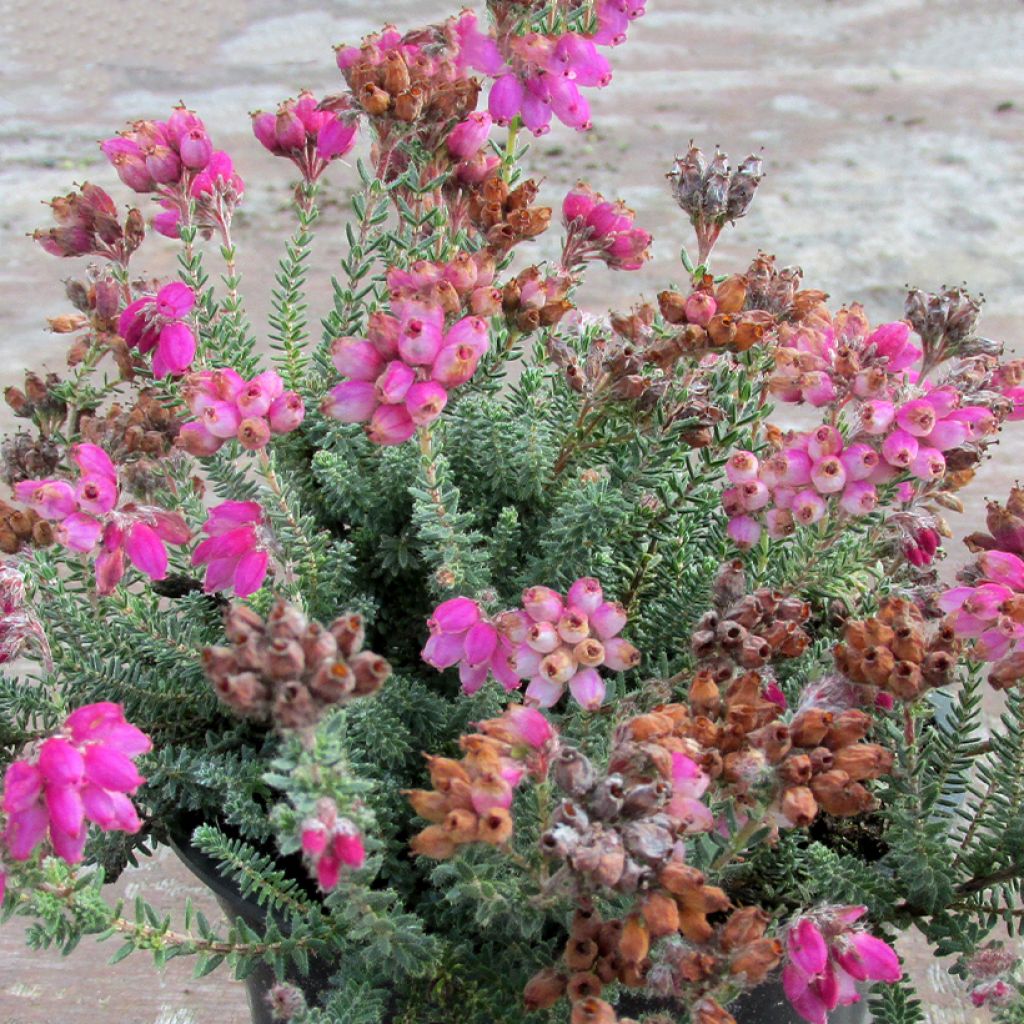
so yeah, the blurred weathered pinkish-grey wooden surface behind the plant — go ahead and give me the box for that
[0,0,1024,1024]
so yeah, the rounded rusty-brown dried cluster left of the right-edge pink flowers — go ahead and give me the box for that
[835,598,958,703]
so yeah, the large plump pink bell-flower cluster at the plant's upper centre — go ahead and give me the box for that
[322,290,489,444]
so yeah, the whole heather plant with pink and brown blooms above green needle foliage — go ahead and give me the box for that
[0,0,1024,1024]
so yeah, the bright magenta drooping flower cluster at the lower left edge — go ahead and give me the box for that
[3,703,152,864]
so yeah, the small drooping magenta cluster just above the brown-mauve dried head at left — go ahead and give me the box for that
[191,502,269,597]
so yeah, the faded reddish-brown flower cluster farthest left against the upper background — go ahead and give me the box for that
[32,181,145,266]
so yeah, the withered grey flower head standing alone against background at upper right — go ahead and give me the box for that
[667,142,764,265]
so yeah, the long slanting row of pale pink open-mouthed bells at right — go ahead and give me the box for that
[722,388,996,554]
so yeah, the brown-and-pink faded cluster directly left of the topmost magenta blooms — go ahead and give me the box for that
[335,24,480,127]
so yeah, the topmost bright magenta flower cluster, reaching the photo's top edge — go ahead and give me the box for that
[451,6,644,135]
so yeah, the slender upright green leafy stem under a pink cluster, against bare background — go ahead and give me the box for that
[269,181,319,391]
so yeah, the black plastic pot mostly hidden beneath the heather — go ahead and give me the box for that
[170,827,870,1024]
